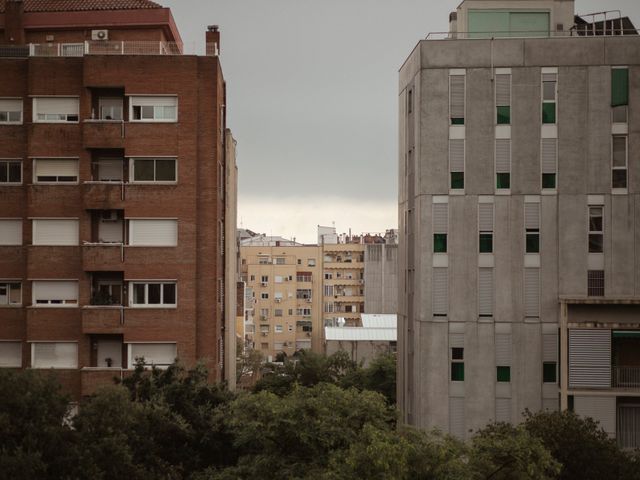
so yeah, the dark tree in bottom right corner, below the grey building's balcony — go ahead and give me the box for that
[524,410,640,480]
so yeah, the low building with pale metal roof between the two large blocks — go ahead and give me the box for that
[324,313,397,366]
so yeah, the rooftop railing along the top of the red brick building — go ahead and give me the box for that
[0,40,218,58]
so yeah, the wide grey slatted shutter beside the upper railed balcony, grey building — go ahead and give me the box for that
[569,329,611,388]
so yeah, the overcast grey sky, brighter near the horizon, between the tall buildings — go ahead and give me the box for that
[162,0,640,242]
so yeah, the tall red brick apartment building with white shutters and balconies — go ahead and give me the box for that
[0,0,236,397]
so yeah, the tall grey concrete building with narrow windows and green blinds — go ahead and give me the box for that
[398,0,640,447]
